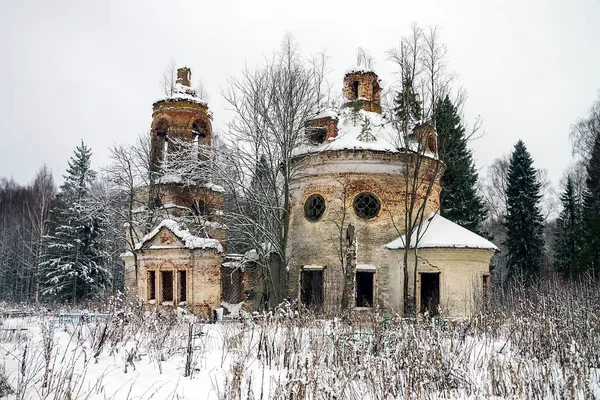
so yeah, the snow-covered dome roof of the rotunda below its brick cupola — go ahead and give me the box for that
[294,107,436,158]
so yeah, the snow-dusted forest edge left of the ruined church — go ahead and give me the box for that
[0,142,124,304]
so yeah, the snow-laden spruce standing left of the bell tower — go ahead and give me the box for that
[41,141,110,303]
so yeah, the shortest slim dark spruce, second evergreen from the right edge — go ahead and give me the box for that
[555,175,583,278]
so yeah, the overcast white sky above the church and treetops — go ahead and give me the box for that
[0,0,600,190]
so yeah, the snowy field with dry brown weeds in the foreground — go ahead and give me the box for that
[0,284,600,400]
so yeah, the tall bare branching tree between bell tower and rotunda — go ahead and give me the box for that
[219,34,326,300]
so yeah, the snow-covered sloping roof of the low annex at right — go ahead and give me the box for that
[384,214,498,251]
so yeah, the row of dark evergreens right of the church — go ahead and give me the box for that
[432,91,600,282]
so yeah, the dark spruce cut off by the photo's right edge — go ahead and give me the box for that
[581,131,600,273]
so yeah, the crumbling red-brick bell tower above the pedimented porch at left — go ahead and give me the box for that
[149,67,227,247]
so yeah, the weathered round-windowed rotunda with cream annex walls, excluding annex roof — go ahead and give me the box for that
[287,68,496,316]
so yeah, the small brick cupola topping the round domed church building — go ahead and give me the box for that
[343,67,381,114]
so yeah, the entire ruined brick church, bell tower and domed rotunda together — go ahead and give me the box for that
[123,67,498,316]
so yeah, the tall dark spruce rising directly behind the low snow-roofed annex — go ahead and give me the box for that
[435,96,486,233]
